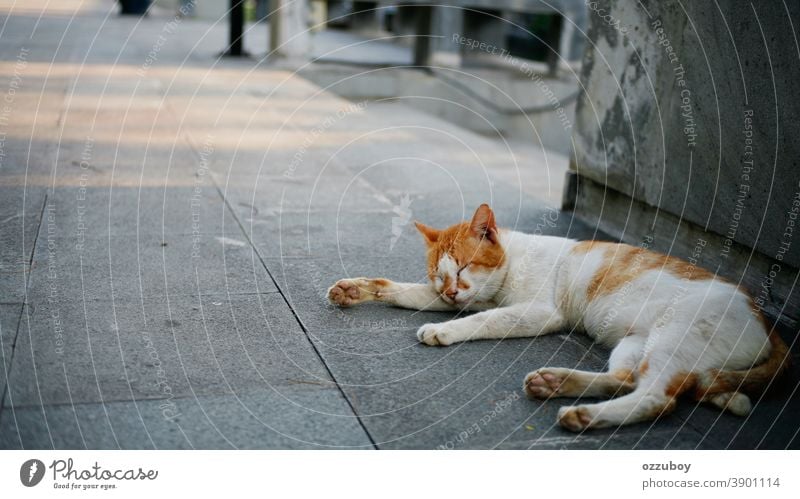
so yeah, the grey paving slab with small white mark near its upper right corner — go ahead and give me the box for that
[29,229,276,301]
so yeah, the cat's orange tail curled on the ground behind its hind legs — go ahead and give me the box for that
[695,323,790,415]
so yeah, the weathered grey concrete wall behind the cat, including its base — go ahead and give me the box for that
[565,0,800,317]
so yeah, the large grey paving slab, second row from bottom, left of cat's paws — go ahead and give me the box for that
[5,293,335,407]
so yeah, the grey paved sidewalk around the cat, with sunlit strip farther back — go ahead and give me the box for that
[0,0,800,449]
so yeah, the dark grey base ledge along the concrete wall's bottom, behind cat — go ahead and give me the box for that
[563,171,800,329]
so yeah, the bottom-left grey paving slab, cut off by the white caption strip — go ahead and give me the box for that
[0,385,372,449]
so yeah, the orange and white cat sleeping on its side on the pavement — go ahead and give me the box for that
[328,204,788,431]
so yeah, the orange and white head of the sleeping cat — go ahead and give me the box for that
[416,204,505,306]
